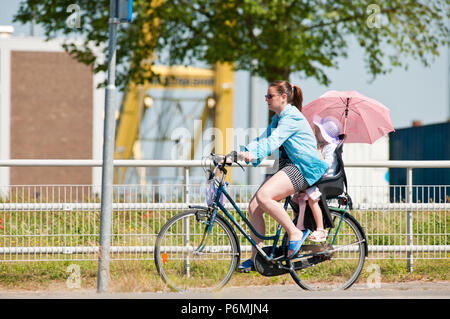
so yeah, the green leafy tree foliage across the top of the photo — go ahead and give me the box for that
[15,0,450,88]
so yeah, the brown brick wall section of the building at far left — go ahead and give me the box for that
[10,51,93,185]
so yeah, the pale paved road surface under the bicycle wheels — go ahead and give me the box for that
[0,281,450,299]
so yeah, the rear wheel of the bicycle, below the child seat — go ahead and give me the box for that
[291,210,367,290]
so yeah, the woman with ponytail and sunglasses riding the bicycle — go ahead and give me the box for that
[239,81,328,270]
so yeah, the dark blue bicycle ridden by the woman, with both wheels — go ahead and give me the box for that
[154,152,368,291]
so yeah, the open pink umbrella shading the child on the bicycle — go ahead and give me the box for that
[302,91,394,144]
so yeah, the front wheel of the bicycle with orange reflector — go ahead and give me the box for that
[154,210,240,291]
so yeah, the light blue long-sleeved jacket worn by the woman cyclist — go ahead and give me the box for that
[241,104,328,185]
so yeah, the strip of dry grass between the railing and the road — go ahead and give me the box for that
[0,259,450,292]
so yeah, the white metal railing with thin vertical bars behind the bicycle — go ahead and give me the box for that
[0,160,450,270]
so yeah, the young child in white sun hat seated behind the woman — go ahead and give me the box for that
[292,116,341,242]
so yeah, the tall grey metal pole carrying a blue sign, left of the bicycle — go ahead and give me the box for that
[97,0,118,292]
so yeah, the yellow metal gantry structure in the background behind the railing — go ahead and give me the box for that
[114,64,234,183]
